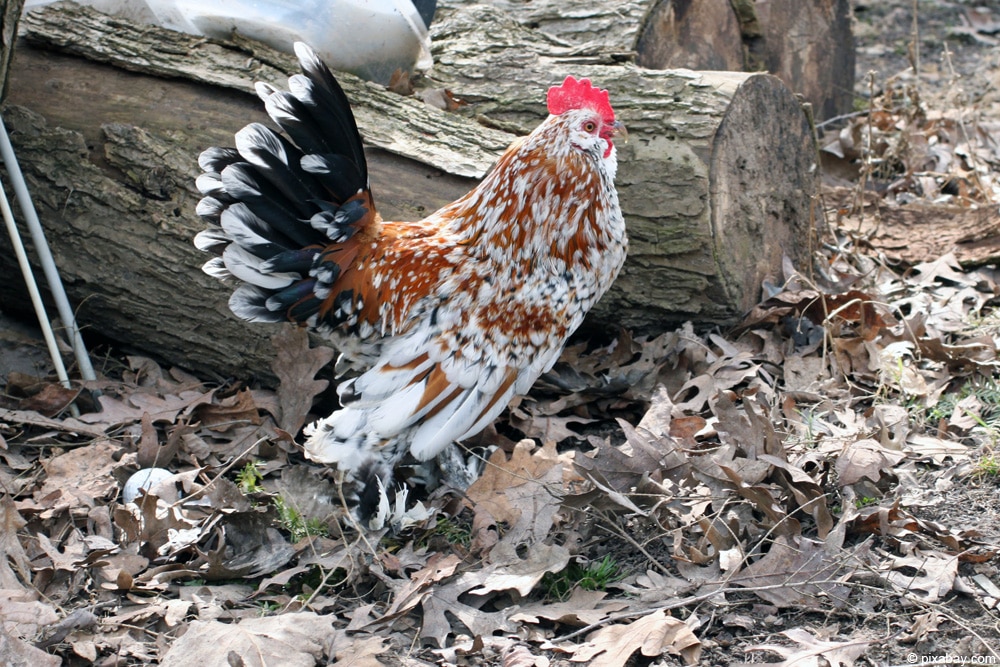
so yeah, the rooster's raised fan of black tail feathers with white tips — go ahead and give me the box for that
[195,44,376,326]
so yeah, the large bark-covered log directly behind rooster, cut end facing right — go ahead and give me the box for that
[0,7,816,376]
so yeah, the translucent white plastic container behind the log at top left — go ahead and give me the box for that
[26,0,432,83]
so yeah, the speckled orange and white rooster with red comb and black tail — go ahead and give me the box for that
[195,44,628,527]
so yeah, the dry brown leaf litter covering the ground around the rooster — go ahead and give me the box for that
[0,3,1000,667]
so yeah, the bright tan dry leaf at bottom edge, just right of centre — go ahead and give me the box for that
[570,611,701,667]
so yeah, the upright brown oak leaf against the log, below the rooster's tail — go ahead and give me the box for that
[271,325,334,437]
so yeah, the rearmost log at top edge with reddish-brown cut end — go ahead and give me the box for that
[438,0,854,118]
